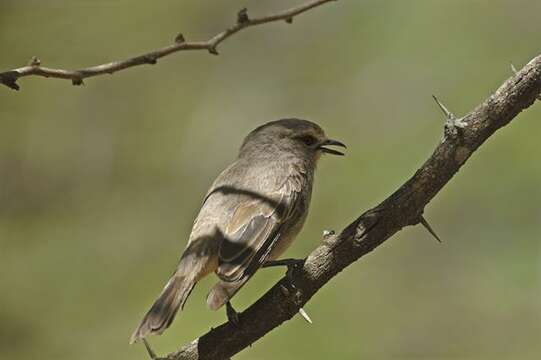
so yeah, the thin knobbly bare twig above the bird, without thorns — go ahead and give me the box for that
[0,0,337,90]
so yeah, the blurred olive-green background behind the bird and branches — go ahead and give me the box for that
[0,0,541,360]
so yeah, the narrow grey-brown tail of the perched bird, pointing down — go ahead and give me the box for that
[130,273,196,344]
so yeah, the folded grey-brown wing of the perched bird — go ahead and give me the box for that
[216,181,301,281]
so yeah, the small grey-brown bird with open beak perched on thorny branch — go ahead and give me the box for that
[130,119,345,343]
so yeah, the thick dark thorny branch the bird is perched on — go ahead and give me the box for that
[155,55,541,360]
